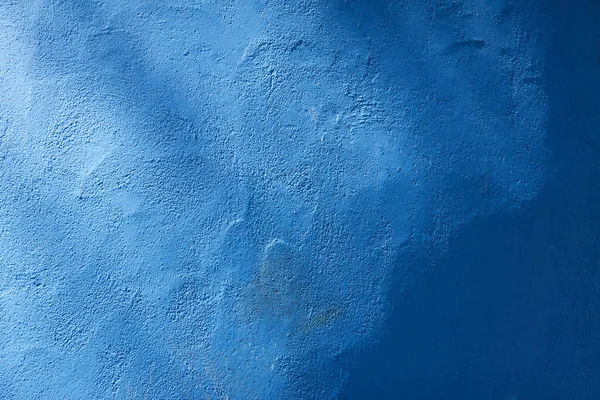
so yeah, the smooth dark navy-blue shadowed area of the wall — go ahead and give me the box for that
[340,1,600,400]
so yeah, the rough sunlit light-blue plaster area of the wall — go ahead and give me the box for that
[0,0,596,399]
